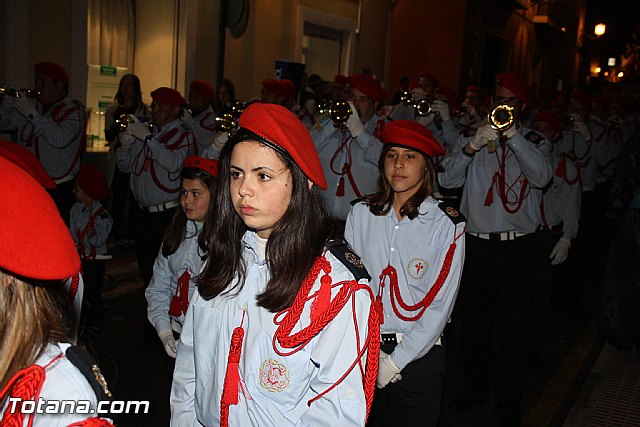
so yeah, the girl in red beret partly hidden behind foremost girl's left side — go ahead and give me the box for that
[145,156,218,373]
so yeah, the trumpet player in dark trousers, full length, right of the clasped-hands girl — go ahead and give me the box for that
[439,74,553,425]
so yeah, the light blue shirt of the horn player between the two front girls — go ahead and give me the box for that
[311,114,384,220]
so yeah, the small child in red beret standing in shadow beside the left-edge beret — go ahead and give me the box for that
[69,164,113,338]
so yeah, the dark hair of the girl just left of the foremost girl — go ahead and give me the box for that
[162,168,216,257]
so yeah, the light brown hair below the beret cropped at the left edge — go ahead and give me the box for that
[0,270,68,389]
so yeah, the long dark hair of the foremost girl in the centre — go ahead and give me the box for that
[197,129,336,312]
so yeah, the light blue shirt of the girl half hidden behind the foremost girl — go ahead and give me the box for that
[144,221,204,332]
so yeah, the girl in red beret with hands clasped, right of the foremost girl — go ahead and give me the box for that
[345,120,465,426]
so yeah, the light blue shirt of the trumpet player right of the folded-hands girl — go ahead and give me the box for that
[438,127,553,233]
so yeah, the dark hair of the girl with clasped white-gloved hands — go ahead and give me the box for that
[364,144,436,219]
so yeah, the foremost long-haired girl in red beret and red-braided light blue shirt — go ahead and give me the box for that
[171,103,379,426]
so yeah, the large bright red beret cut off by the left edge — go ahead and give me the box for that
[0,158,80,280]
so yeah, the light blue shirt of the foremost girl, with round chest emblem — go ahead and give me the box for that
[171,232,372,427]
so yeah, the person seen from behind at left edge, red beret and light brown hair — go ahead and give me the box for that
[0,157,112,427]
